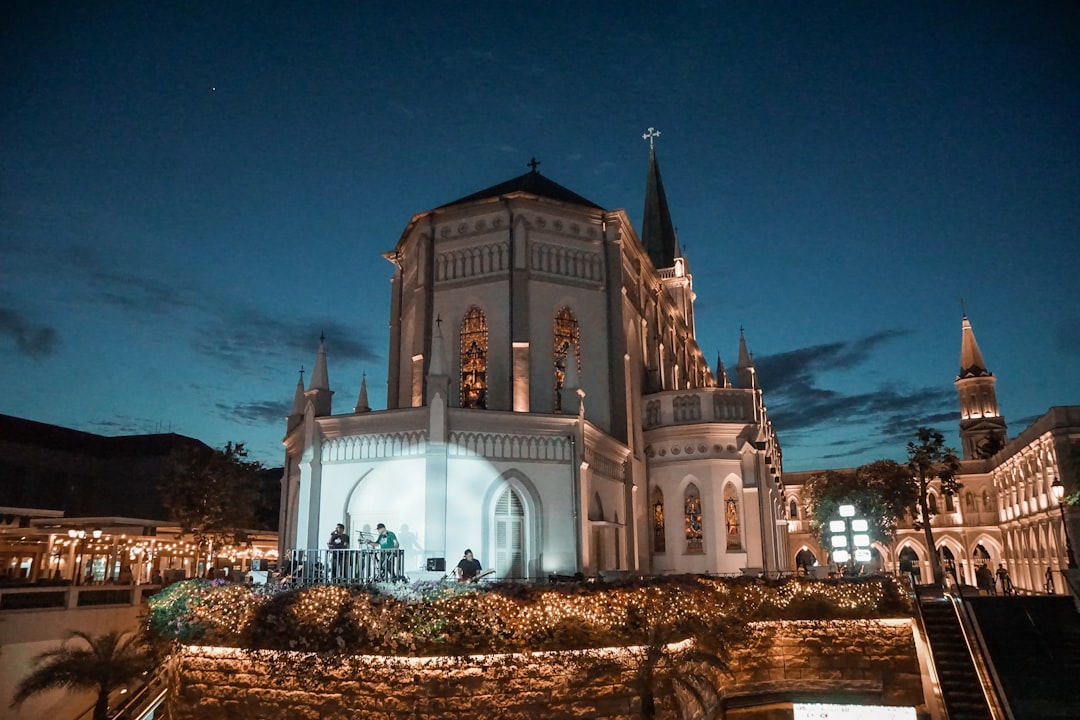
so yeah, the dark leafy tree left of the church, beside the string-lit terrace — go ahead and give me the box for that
[160,443,262,561]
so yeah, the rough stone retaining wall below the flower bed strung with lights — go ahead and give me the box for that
[168,621,923,720]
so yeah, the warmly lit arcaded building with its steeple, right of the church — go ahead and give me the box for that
[784,316,1080,593]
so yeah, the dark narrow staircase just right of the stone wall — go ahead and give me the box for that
[919,597,994,720]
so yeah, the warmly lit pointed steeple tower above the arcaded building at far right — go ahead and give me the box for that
[954,314,1009,460]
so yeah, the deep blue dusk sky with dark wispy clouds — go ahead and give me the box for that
[0,0,1080,471]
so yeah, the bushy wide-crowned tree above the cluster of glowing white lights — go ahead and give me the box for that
[805,460,918,547]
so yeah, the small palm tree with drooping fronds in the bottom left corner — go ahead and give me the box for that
[11,630,150,720]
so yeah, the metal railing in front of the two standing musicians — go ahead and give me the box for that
[282,548,407,586]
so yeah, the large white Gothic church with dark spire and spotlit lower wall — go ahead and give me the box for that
[280,144,791,580]
